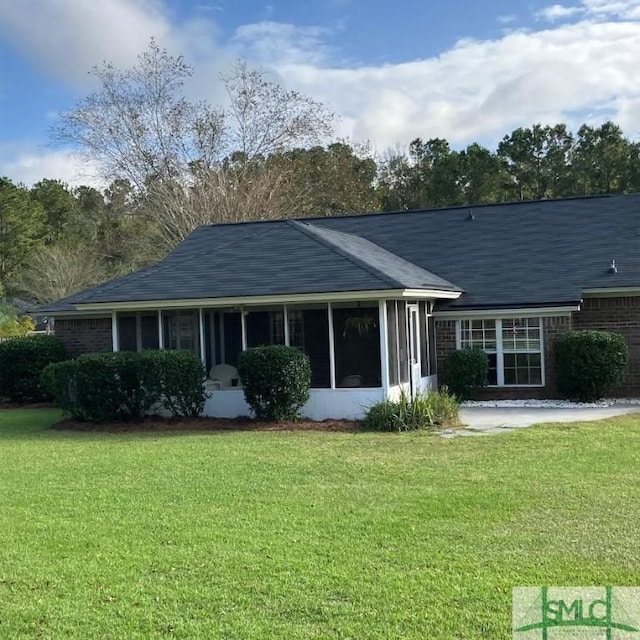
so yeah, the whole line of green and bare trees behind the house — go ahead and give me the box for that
[0,41,640,303]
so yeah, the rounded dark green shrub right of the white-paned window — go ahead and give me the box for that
[555,331,629,402]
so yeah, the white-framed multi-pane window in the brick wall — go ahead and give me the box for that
[459,318,543,386]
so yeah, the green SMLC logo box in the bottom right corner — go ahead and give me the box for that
[513,587,640,640]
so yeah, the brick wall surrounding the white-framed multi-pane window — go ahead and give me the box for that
[436,316,572,400]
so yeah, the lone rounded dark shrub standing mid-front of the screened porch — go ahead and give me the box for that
[238,345,311,420]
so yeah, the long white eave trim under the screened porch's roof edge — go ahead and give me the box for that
[70,289,462,315]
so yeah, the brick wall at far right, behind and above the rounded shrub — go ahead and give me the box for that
[573,296,640,396]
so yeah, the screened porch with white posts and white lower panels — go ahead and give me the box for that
[105,291,457,420]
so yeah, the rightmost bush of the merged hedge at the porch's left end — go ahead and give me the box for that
[142,351,207,418]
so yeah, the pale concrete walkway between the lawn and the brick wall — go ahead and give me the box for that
[441,405,640,438]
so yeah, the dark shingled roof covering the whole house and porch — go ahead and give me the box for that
[36,194,640,311]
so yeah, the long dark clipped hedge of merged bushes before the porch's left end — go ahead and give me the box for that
[42,351,205,422]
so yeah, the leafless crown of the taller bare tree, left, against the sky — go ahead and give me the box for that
[52,39,225,191]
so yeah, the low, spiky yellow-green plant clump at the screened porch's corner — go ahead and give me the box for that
[362,387,460,431]
